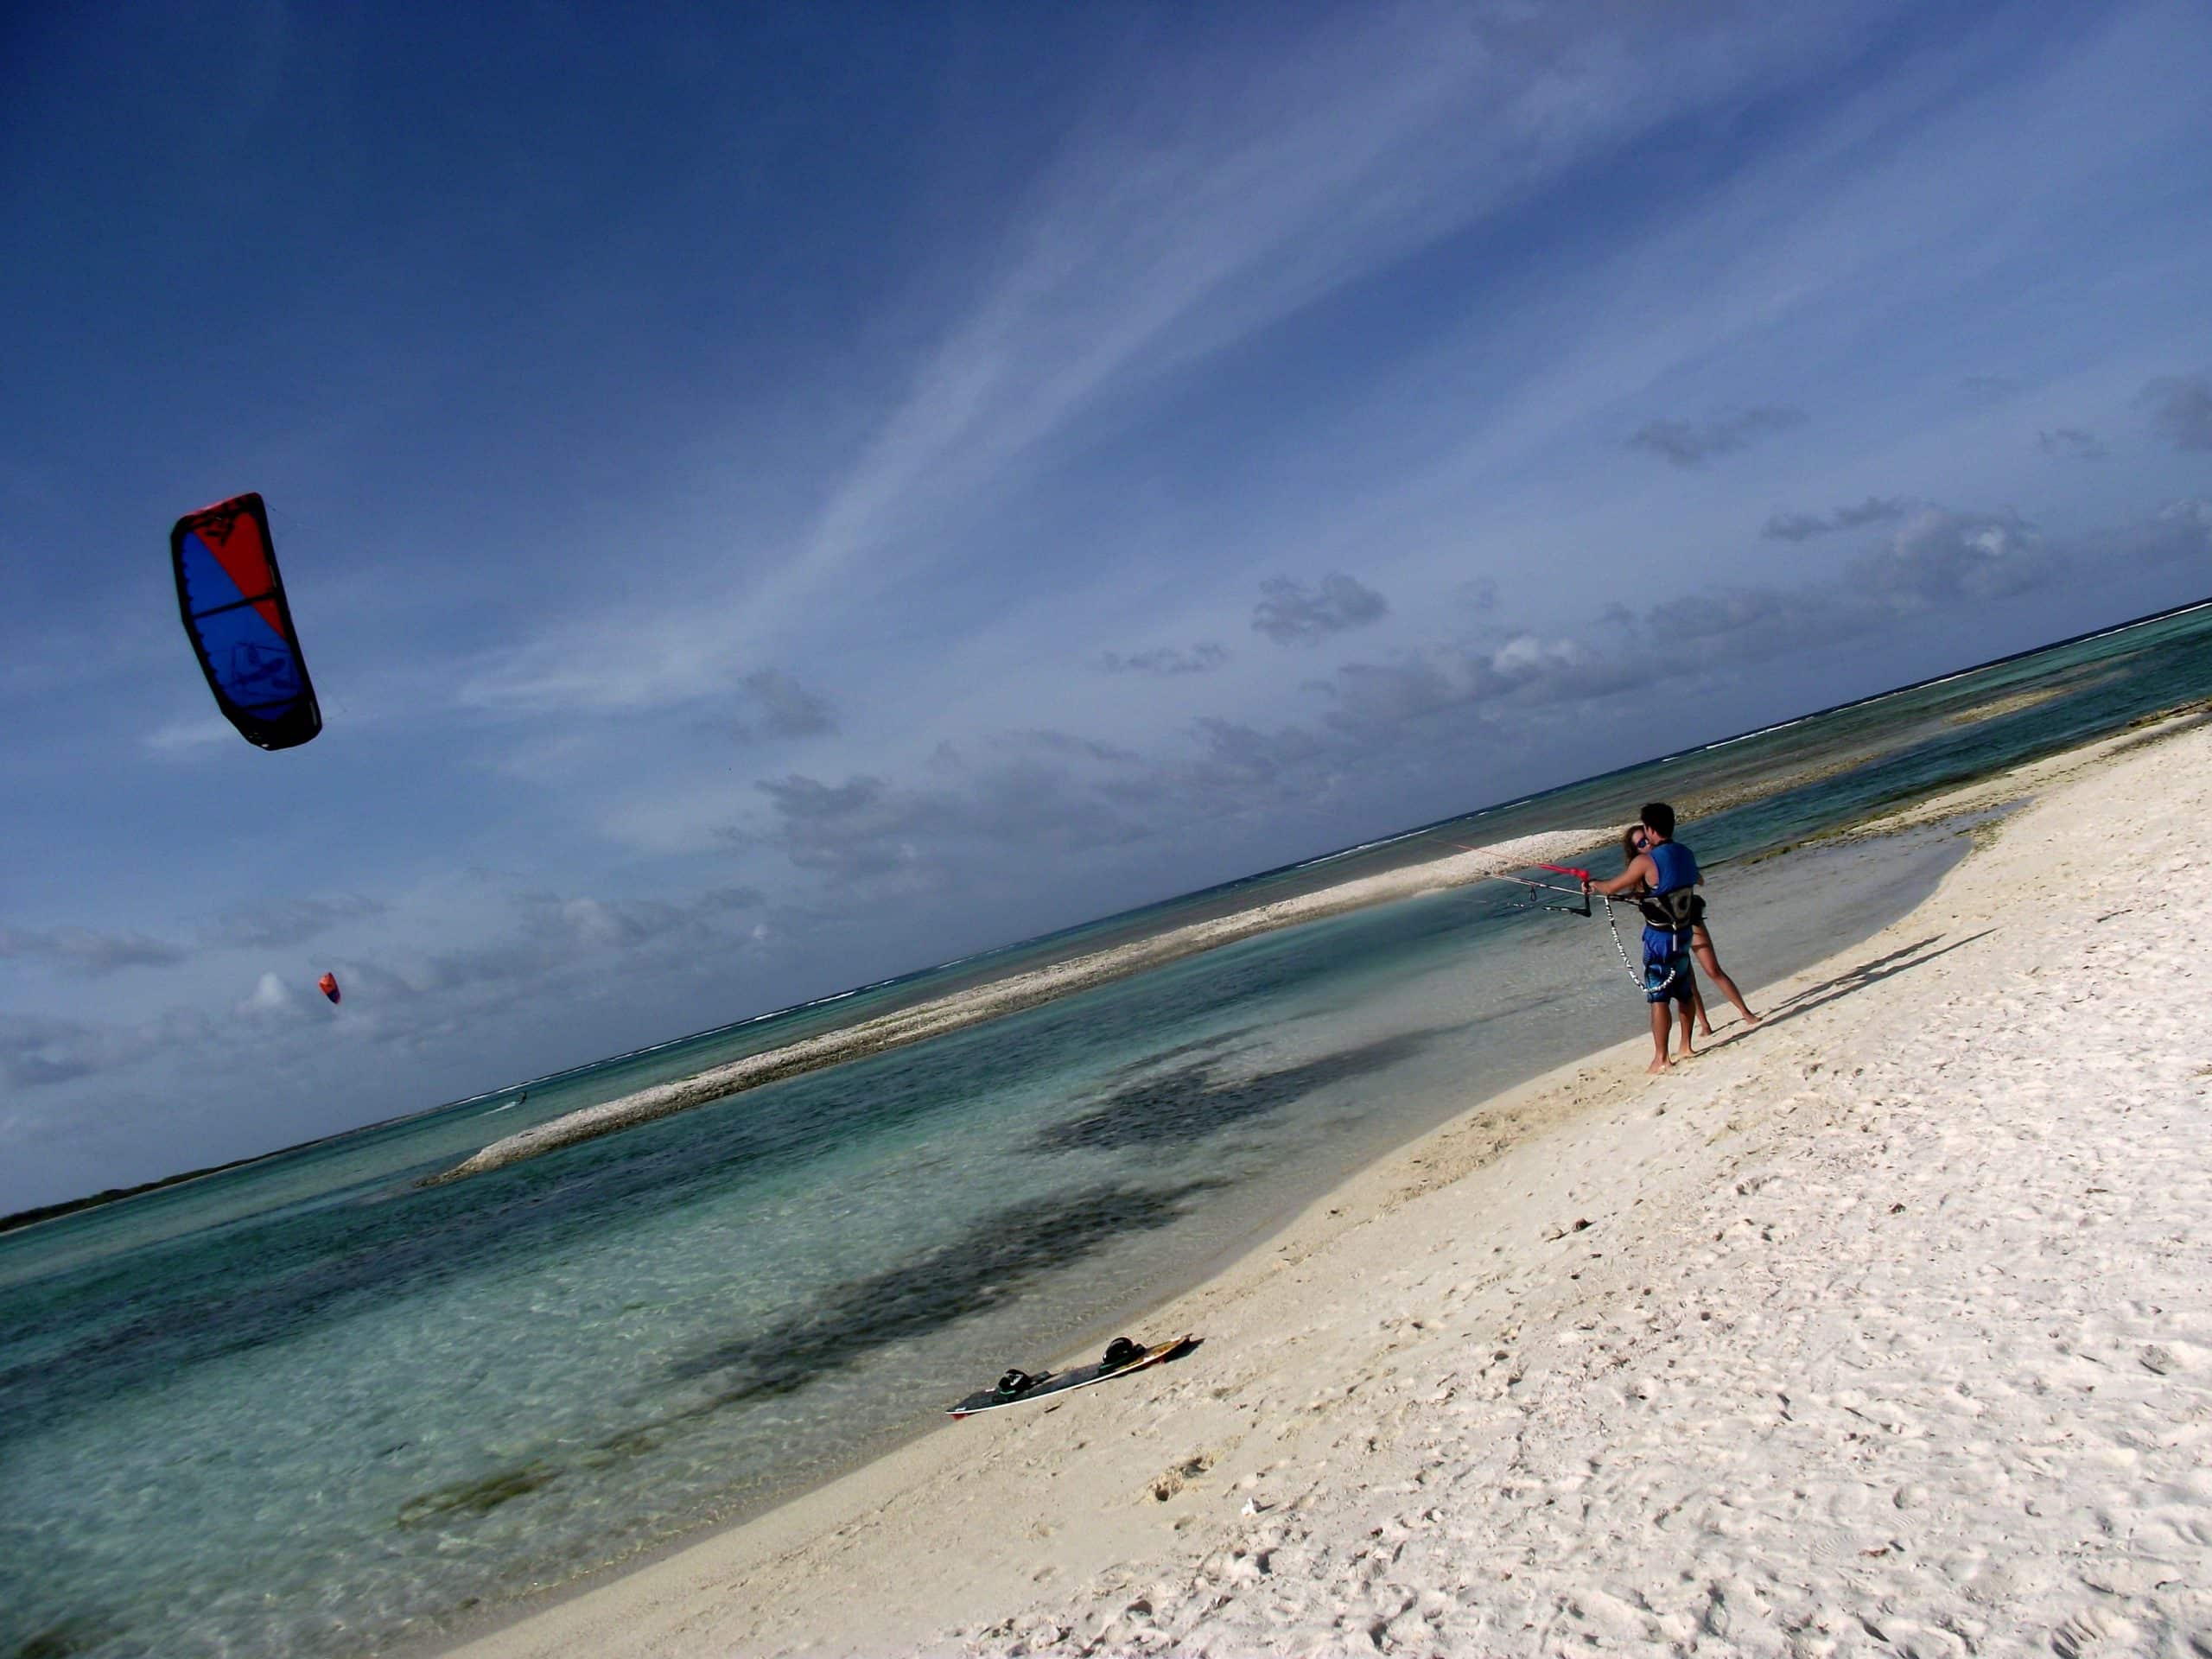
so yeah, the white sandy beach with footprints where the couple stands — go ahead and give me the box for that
[448,715,2212,1659]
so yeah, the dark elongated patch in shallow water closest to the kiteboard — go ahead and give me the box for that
[668,1181,1228,1405]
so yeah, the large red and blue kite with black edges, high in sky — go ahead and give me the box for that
[168,493,323,750]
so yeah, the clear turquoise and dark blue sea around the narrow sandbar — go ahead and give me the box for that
[0,608,2212,1656]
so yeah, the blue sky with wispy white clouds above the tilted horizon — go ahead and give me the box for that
[0,3,2212,1208]
